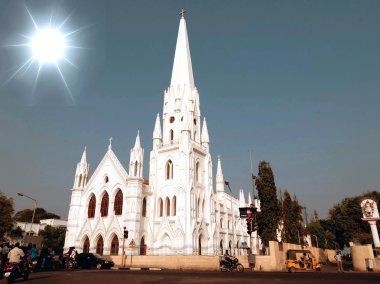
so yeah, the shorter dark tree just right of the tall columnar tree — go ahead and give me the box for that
[281,190,304,244]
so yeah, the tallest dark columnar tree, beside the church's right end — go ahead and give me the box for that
[256,161,281,246]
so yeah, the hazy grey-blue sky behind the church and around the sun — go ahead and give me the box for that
[0,0,380,219]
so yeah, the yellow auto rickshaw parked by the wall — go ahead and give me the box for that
[286,249,321,272]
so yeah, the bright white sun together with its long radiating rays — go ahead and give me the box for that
[0,6,83,103]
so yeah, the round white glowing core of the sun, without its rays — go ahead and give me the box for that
[31,28,66,63]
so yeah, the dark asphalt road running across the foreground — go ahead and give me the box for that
[7,270,380,284]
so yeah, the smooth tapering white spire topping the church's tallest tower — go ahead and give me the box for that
[170,9,194,87]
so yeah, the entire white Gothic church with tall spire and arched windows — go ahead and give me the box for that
[65,14,256,255]
